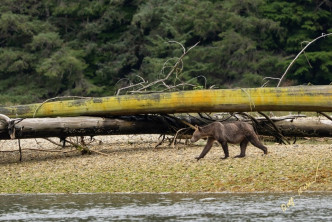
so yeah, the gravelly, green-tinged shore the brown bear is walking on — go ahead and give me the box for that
[0,135,332,193]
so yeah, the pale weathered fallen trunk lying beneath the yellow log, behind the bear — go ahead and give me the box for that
[0,115,332,139]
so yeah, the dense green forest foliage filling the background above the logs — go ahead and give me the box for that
[0,0,332,104]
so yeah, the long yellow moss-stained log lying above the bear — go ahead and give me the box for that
[0,86,332,118]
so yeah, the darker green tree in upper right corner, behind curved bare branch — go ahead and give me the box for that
[261,0,332,84]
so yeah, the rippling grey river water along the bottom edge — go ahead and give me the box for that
[0,192,332,221]
